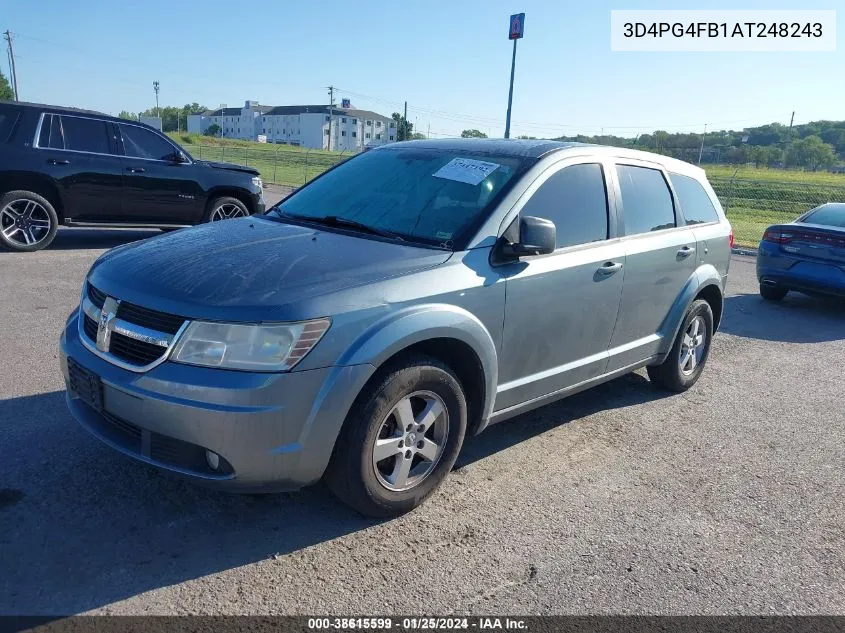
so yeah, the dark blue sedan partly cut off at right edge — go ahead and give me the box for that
[757,202,845,301]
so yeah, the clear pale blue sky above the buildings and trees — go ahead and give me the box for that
[0,0,845,138]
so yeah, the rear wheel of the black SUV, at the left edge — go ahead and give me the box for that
[0,190,59,253]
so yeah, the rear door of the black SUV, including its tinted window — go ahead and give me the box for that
[36,113,123,222]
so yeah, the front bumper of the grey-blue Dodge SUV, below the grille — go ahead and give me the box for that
[60,313,374,492]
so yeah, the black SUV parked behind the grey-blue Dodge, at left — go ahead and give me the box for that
[0,101,264,251]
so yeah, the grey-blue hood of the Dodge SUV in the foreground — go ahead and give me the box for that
[88,216,451,322]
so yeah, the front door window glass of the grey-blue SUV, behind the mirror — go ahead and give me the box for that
[520,163,607,248]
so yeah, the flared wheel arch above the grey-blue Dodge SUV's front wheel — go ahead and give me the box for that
[338,303,499,426]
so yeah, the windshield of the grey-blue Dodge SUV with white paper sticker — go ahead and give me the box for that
[276,148,526,248]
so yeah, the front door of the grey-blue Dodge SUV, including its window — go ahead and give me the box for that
[495,162,625,411]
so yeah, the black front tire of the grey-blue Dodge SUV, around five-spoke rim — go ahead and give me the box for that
[324,355,467,517]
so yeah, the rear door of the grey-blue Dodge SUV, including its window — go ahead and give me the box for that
[608,159,696,371]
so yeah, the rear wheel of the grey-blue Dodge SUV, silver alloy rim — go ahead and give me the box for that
[646,299,713,392]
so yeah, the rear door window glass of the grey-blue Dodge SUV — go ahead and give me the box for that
[616,165,675,235]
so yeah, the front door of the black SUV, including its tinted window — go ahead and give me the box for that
[116,123,203,224]
